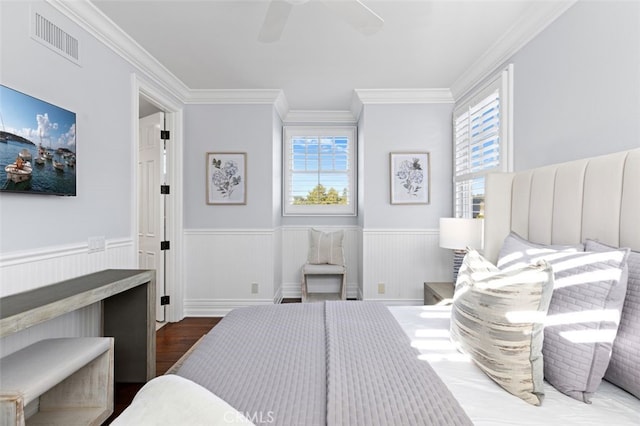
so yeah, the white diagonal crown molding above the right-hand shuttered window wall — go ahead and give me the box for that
[451,0,578,101]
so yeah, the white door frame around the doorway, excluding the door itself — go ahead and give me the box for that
[131,73,184,322]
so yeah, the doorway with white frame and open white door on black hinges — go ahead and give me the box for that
[131,74,184,322]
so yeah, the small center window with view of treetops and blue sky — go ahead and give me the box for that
[282,126,356,216]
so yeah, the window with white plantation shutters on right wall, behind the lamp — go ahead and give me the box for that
[453,65,513,218]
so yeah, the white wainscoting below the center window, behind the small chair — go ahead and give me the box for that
[282,226,360,299]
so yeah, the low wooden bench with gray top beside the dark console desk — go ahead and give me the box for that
[0,337,114,426]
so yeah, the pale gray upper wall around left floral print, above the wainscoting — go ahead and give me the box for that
[184,105,278,229]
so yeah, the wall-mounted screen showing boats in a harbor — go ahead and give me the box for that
[0,85,76,196]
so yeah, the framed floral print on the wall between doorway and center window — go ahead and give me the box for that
[206,152,247,205]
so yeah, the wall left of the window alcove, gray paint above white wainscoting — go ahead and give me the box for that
[184,104,280,315]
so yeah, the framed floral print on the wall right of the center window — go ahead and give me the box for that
[389,152,431,204]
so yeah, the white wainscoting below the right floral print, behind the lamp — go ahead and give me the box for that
[362,229,452,305]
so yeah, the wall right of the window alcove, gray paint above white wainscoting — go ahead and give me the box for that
[359,104,453,304]
